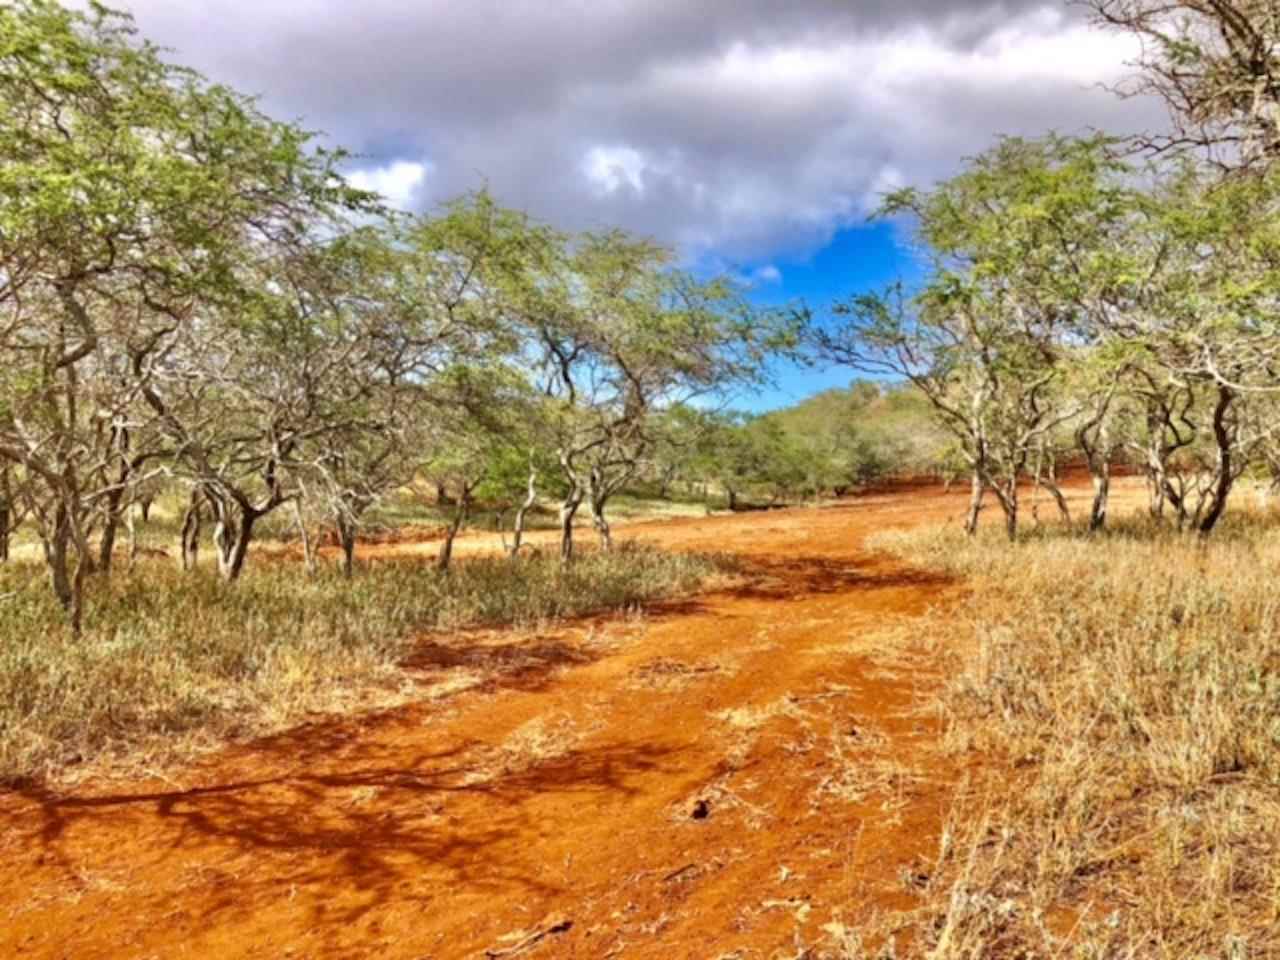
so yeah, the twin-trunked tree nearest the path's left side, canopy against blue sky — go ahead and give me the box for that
[521,232,774,562]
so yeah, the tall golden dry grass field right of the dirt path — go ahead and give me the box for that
[865,516,1280,960]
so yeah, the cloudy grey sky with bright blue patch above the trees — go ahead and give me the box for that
[120,0,1164,408]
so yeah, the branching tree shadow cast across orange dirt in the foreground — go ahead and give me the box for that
[15,724,678,955]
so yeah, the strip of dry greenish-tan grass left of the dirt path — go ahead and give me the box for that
[0,545,726,782]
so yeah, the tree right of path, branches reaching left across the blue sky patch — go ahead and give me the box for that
[812,137,1126,538]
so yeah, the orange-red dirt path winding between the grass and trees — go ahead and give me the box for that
[0,492,963,960]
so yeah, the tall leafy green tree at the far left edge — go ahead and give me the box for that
[0,0,373,631]
